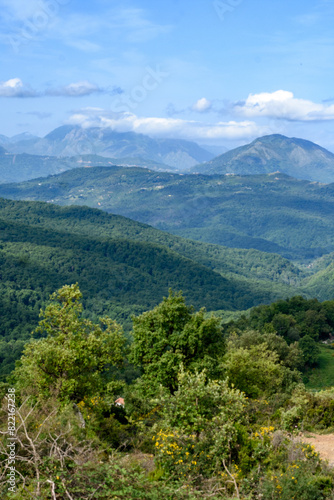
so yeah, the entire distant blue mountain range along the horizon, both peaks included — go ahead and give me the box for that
[0,129,334,183]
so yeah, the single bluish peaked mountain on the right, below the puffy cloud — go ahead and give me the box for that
[191,134,334,183]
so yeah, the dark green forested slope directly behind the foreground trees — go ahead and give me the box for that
[0,199,305,373]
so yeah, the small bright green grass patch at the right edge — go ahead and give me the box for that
[304,345,334,391]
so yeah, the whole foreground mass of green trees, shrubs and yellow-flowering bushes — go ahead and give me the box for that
[0,285,334,500]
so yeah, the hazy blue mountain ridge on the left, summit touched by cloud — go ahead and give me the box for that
[0,125,214,170]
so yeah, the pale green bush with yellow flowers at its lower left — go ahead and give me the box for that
[154,370,247,476]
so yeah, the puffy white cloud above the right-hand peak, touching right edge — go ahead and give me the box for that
[233,90,334,122]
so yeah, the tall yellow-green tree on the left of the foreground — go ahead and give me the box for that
[14,284,125,402]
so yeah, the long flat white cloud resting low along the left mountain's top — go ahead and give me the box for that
[69,108,268,140]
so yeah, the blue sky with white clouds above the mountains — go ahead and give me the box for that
[0,0,334,151]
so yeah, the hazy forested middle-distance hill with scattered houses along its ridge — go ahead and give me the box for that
[0,167,334,261]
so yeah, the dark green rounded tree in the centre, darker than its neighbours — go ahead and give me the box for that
[132,290,224,392]
